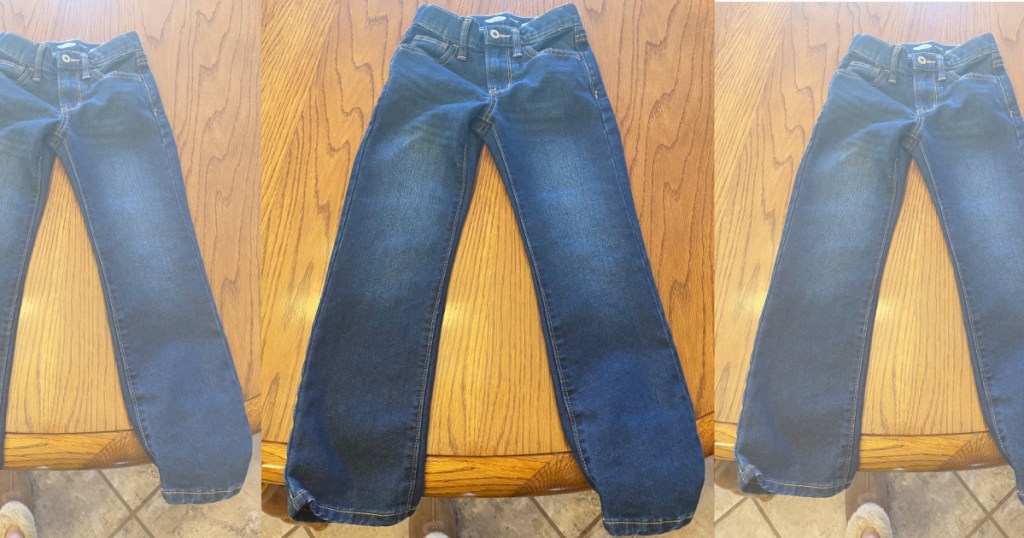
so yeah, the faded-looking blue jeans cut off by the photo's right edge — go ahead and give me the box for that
[736,34,1024,500]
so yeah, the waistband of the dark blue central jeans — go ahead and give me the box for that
[413,3,583,49]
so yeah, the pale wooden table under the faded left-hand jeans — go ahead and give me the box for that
[0,0,260,469]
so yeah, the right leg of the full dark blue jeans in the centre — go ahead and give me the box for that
[484,56,705,536]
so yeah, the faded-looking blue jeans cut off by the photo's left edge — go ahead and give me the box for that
[0,33,252,503]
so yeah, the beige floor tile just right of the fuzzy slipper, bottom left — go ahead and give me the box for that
[30,470,129,536]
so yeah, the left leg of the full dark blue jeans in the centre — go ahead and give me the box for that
[285,49,485,526]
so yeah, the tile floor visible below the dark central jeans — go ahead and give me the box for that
[263,458,714,538]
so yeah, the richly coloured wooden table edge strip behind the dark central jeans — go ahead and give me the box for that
[260,412,715,497]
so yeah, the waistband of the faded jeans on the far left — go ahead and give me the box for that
[0,32,142,72]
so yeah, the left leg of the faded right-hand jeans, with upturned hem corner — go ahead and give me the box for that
[736,73,915,497]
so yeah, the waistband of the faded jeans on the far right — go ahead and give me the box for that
[850,34,999,74]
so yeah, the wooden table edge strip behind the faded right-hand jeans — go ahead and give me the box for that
[715,422,1006,471]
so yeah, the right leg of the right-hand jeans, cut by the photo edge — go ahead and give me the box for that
[914,74,1024,501]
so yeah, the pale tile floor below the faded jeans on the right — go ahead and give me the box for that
[715,466,1024,538]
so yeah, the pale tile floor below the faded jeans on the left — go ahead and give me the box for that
[30,436,260,538]
